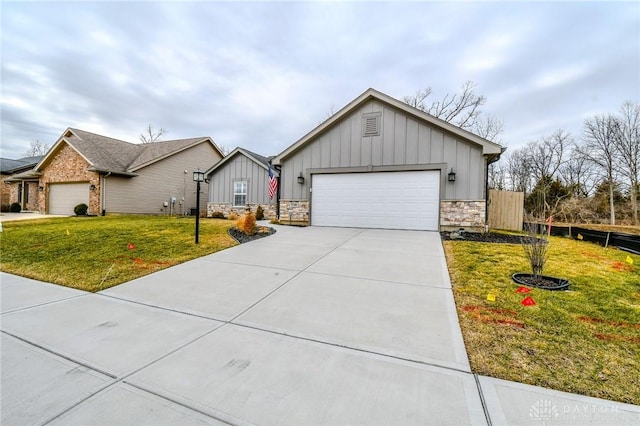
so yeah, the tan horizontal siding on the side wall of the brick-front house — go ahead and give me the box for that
[102,141,220,214]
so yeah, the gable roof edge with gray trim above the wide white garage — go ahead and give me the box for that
[273,88,504,164]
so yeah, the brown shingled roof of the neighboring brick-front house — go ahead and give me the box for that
[36,128,222,176]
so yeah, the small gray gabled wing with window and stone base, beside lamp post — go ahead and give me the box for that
[205,147,277,219]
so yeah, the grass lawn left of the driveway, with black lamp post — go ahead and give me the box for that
[0,216,236,292]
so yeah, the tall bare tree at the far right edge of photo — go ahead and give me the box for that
[614,101,640,225]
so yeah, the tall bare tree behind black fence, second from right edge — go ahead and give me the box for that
[580,114,618,225]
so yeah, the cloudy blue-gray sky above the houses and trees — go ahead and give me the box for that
[0,1,640,158]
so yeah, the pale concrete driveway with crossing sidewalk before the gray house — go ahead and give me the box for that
[1,227,640,425]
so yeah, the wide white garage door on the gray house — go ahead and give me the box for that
[311,170,440,231]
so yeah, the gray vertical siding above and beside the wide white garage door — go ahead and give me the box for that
[280,100,485,200]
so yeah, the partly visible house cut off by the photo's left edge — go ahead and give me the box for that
[0,155,42,211]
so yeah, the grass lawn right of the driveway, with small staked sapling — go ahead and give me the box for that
[443,237,640,405]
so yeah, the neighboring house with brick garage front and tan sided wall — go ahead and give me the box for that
[5,128,223,215]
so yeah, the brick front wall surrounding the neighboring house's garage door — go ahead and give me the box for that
[38,143,100,214]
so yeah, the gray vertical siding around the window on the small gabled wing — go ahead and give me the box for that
[209,152,272,204]
